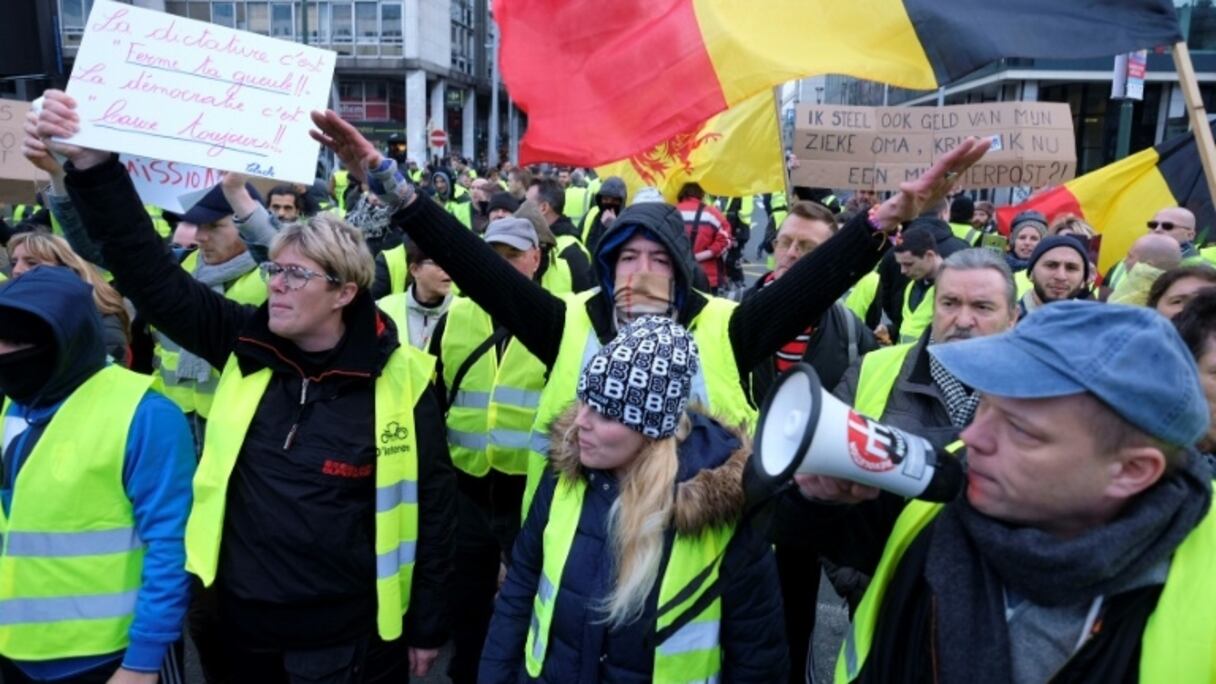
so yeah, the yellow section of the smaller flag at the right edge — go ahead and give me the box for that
[1064,147,1178,273]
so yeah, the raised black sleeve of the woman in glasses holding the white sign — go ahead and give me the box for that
[67,156,257,368]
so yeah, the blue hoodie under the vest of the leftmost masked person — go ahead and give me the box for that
[0,267,195,680]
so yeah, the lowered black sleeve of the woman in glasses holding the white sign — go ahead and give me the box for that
[405,385,456,649]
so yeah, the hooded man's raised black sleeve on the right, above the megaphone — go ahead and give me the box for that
[731,214,888,374]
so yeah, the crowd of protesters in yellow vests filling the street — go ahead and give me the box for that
[0,91,1216,684]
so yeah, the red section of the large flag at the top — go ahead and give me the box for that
[494,0,726,167]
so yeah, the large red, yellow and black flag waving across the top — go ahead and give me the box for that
[494,0,1181,167]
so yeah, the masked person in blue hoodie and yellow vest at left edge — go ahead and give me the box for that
[0,265,195,682]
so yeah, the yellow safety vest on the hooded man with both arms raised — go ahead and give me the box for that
[523,287,756,516]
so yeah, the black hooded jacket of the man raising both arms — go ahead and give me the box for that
[393,194,885,379]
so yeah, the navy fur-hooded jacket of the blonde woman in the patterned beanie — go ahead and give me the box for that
[478,410,789,684]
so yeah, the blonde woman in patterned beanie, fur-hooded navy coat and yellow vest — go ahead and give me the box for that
[478,316,789,684]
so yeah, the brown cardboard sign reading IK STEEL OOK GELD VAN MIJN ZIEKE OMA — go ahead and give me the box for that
[790,102,1076,190]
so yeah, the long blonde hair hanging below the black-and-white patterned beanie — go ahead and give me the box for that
[564,416,691,627]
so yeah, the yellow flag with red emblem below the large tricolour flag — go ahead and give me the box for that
[596,90,786,202]
